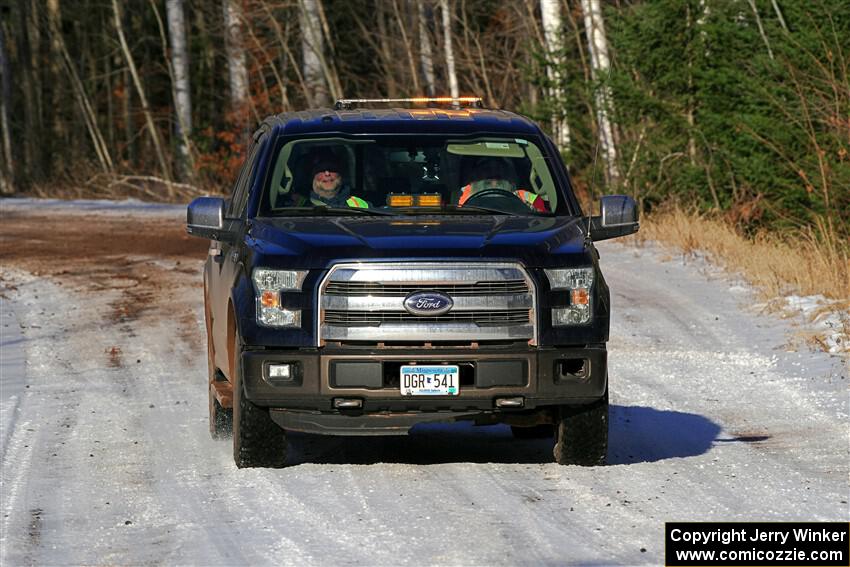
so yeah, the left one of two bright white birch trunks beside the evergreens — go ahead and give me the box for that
[540,0,572,150]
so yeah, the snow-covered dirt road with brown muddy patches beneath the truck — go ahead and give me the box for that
[0,201,850,565]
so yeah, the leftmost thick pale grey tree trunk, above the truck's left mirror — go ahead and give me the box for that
[165,0,194,180]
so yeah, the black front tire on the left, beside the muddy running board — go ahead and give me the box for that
[233,337,286,469]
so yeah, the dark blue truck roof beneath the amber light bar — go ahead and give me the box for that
[266,108,540,136]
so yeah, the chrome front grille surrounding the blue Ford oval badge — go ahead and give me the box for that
[316,261,537,346]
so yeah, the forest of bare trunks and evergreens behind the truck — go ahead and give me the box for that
[0,0,850,300]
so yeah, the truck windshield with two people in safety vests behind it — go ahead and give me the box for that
[255,136,566,216]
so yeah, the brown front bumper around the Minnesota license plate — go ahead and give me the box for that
[242,344,608,435]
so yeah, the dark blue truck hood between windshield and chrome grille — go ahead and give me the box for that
[246,215,589,268]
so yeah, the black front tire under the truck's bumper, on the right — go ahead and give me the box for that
[553,389,608,467]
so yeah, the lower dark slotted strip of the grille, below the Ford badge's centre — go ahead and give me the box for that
[325,309,529,327]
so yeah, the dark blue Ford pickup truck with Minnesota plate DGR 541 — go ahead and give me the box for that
[187,101,638,467]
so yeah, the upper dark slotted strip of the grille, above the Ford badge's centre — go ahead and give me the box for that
[325,280,528,297]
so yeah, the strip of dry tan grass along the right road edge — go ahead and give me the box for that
[636,207,850,309]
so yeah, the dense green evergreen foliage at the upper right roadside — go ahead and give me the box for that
[607,0,850,235]
